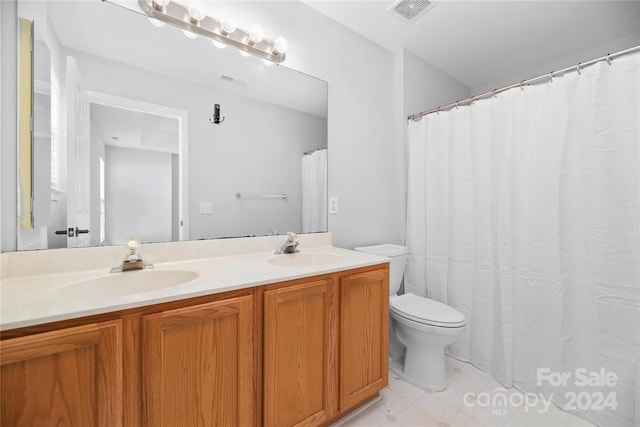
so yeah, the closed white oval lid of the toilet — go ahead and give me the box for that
[389,293,465,328]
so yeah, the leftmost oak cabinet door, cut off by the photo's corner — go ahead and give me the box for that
[0,320,122,427]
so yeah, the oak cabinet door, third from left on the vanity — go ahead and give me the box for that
[263,279,338,426]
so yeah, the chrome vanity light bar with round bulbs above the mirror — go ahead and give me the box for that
[138,0,289,64]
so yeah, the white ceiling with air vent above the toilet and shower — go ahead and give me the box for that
[303,0,640,88]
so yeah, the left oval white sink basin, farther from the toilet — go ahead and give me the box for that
[57,270,198,298]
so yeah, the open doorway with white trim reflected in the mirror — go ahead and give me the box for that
[89,93,182,245]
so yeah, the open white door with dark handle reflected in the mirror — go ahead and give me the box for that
[66,57,92,248]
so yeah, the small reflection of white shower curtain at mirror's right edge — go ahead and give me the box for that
[302,148,327,233]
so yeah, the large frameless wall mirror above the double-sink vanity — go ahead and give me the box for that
[17,0,327,250]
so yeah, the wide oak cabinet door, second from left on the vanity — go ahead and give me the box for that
[142,295,256,427]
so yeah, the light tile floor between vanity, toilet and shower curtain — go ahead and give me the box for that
[338,357,593,427]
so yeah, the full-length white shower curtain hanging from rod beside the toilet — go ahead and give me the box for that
[405,53,640,426]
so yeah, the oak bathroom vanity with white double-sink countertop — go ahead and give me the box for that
[0,233,389,426]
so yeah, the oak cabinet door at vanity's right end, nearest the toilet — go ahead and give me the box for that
[340,269,389,411]
